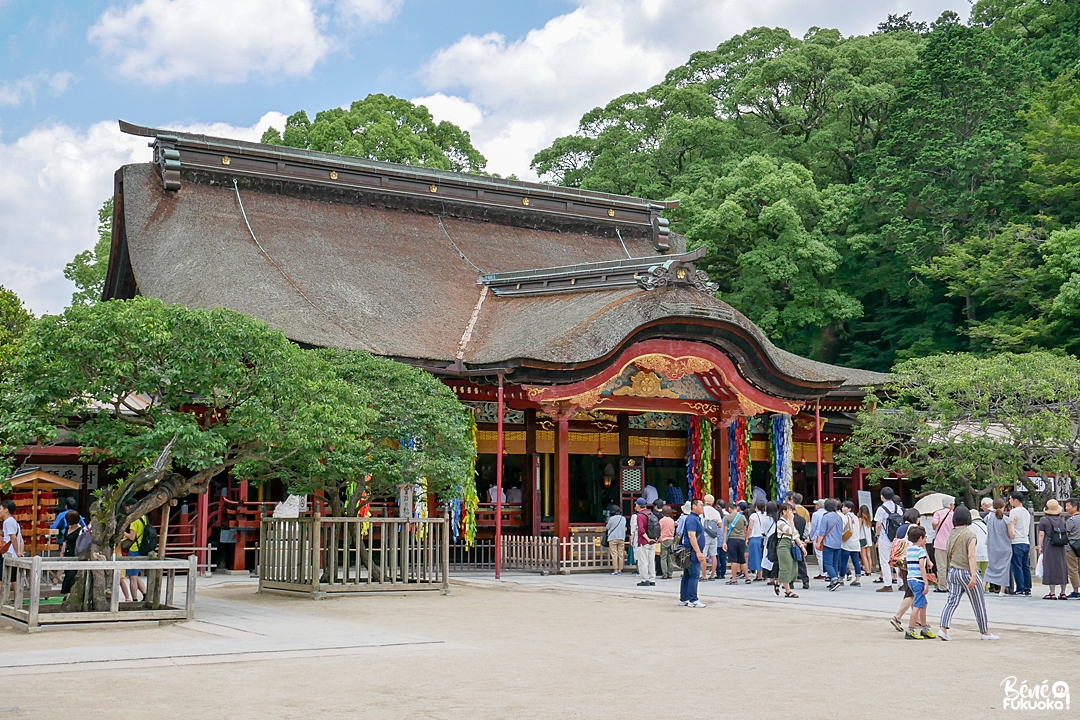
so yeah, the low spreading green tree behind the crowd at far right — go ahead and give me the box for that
[838,352,1080,507]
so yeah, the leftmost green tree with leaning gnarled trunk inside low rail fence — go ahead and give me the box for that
[0,298,370,556]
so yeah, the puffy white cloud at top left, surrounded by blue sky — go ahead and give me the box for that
[87,0,402,84]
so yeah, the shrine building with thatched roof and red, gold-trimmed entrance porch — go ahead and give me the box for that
[105,123,885,538]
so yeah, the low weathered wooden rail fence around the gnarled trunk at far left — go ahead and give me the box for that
[0,555,198,633]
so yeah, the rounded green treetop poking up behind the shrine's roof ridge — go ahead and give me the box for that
[262,94,487,173]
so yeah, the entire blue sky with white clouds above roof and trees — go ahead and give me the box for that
[0,0,969,314]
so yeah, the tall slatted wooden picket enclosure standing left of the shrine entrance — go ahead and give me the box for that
[259,515,450,597]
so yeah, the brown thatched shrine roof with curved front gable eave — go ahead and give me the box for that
[106,131,883,397]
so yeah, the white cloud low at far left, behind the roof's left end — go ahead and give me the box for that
[0,112,285,314]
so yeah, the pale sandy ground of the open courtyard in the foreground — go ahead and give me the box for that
[0,583,1080,720]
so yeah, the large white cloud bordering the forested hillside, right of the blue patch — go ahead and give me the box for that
[418,0,969,177]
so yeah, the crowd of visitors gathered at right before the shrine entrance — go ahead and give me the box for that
[604,487,1080,640]
